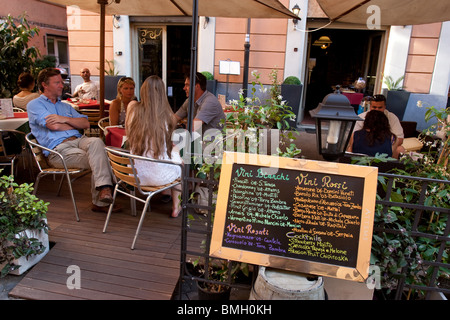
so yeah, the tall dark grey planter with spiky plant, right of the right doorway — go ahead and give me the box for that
[383,76,411,121]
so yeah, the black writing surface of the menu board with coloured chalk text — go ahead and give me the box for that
[222,164,368,267]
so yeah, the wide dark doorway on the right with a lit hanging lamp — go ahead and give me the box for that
[302,29,384,124]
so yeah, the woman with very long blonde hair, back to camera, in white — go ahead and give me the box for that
[125,76,182,218]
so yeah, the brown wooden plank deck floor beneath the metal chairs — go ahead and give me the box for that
[10,175,181,300]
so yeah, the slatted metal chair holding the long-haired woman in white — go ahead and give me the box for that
[103,147,184,250]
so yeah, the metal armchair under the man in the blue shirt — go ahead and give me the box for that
[25,133,90,221]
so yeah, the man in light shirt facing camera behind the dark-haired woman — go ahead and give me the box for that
[353,94,405,154]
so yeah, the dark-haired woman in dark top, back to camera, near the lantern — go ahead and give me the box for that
[347,110,399,159]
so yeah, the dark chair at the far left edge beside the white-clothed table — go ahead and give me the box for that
[0,129,25,175]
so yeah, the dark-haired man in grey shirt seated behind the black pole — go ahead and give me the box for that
[174,72,225,134]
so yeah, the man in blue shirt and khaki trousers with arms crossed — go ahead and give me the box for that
[27,68,119,212]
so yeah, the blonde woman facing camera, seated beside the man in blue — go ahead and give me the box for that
[109,77,136,126]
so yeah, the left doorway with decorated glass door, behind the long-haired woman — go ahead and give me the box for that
[136,25,191,112]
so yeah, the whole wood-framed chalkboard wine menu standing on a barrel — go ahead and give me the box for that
[210,152,378,282]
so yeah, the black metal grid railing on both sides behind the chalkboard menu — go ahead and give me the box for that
[180,171,450,299]
